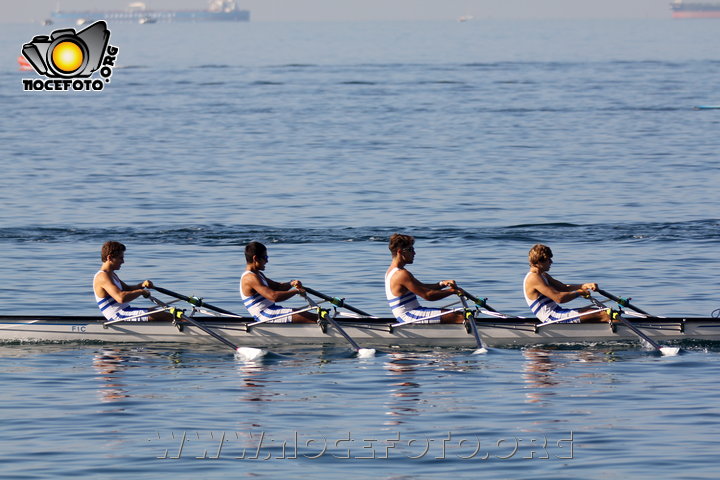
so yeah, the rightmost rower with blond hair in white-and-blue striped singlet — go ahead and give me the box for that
[523,244,610,323]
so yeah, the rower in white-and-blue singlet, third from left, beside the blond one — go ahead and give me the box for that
[385,233,464,323]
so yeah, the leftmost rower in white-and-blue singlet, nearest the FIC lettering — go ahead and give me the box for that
[93,241,172,322]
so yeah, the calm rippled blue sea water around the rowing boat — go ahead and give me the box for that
[0,20,720,479]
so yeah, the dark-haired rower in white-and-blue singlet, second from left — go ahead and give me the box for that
[240,242,317,323]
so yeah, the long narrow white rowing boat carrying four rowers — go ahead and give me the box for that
[0,315,720,347]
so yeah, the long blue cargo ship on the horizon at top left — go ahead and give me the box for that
[50,0,250,25]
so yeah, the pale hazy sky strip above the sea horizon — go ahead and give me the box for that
[7,0,671,22]
